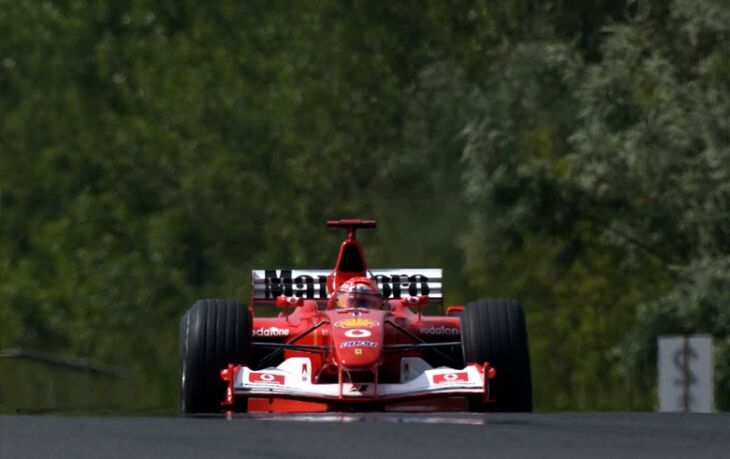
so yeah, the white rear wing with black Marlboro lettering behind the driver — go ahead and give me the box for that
[251,269,443,305]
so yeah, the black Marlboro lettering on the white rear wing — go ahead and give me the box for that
[264,269,431,300]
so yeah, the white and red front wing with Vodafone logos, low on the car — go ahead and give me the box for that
[221,357,495,408]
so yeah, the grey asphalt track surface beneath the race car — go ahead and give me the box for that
[0,413,730,459]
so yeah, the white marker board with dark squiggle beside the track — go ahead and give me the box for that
[657,335,715,413]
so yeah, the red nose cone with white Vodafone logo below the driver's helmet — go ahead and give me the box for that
[327,309,385,369]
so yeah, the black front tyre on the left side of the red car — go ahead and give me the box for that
[180,300,252,413]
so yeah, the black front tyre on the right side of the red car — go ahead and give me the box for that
[461,299,532,412]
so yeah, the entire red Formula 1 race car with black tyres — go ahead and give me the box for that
[180,220,532,413]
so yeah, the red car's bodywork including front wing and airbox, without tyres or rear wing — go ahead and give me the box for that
[221,220,495,412]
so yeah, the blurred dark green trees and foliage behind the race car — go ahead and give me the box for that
[0,0,730,410]
